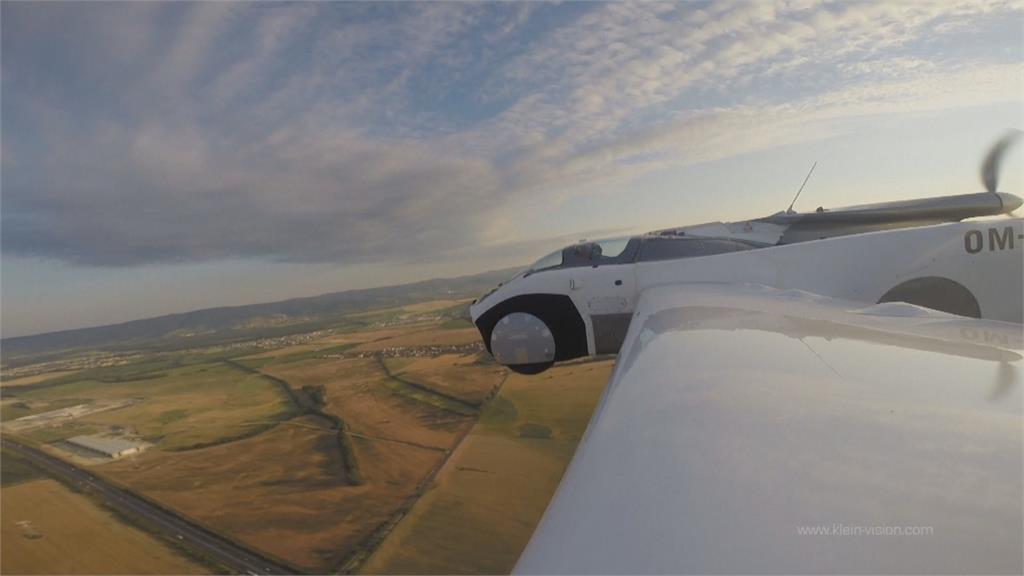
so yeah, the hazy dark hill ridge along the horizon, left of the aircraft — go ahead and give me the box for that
[0,269,514,366]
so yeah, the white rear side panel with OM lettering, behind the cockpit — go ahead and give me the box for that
[636,218,1024,323]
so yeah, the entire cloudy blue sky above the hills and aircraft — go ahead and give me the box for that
[0,0,1024,337]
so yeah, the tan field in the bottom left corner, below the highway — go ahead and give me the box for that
[0,480,210,574]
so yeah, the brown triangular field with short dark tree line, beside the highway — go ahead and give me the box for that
[96,417,443,573]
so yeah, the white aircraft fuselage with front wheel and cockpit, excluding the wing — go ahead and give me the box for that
[470,216,1024,373]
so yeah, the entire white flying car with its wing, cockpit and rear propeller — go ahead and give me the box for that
[485,133,1024,574]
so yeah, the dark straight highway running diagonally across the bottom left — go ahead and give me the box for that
[0,438,296,575]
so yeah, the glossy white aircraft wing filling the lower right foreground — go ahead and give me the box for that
[515,284,1024,574]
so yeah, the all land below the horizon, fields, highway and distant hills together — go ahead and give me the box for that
[0,271,611,574]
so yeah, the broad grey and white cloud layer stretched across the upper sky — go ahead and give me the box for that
[0,2,1021,265]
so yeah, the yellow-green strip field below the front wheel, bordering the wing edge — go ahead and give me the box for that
[359,361,612,574]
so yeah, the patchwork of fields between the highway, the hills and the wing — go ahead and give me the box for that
[3,289,609,573]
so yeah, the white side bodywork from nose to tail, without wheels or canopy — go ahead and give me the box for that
[470,218,1024,354]
